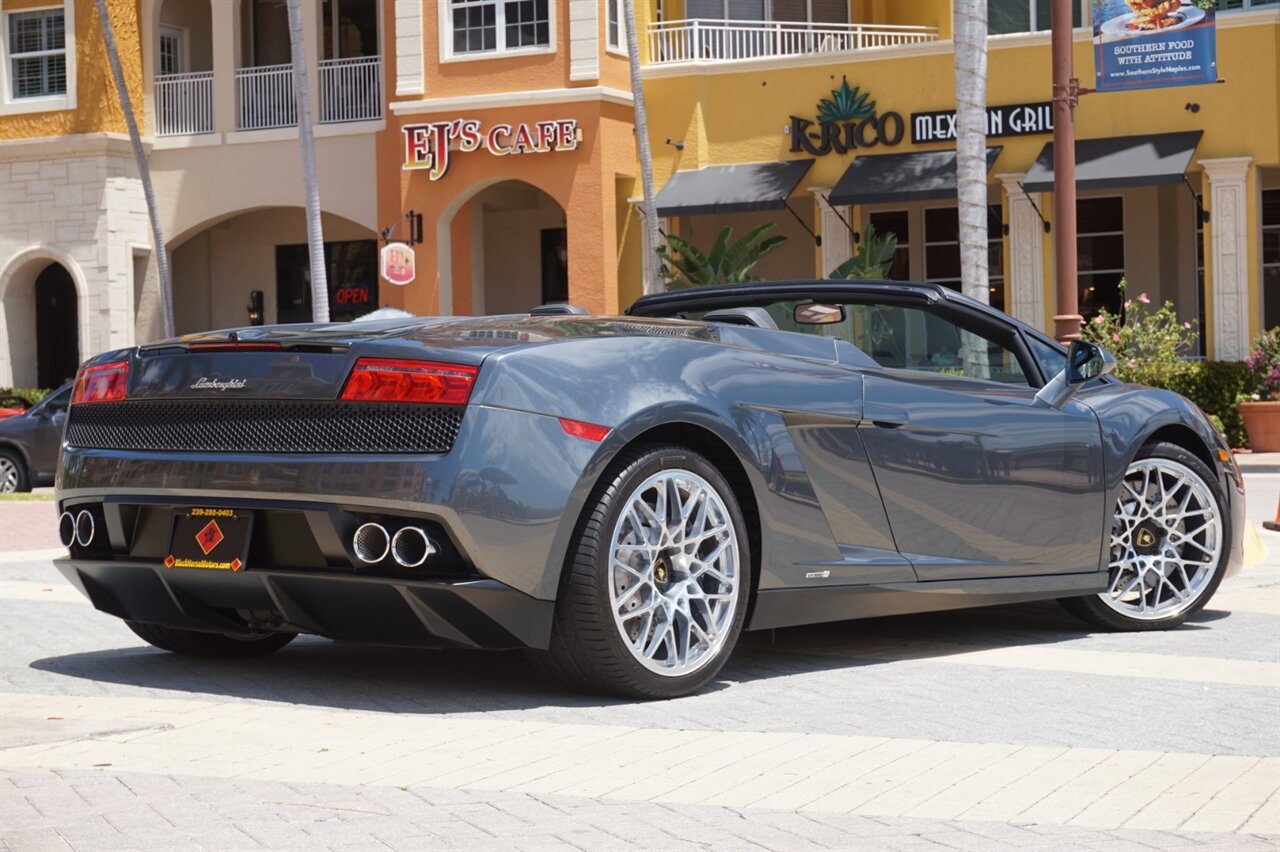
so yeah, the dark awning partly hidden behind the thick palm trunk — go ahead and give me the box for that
[827,145,1004,206]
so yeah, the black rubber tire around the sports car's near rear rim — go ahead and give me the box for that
[532,445,751,698]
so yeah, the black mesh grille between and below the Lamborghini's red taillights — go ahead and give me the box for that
[67,399,466,453]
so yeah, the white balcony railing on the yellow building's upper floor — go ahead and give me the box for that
[649,18,938,65]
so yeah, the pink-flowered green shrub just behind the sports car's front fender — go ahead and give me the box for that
[1080,280,1198,388]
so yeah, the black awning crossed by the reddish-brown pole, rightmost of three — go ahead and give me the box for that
[1023,130,1204,192]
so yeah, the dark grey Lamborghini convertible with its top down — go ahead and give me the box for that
[58,281,1244,697]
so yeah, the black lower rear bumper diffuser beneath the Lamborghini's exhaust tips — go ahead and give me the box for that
[54,559,554,650]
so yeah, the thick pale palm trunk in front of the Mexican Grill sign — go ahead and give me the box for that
[952,0,991,302]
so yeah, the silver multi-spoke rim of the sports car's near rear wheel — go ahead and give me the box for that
[608,468,742,677]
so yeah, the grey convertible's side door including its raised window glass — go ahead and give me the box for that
[844,296,1106,581]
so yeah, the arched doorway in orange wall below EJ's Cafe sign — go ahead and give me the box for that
[453,180,568,313]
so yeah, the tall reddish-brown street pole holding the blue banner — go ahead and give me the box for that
[1050,0,1084,343]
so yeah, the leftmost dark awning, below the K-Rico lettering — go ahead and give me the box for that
[654,160,813,216]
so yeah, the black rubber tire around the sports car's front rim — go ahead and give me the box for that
[1059,443,1231,632]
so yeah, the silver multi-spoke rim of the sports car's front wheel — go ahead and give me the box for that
[1098,457,1225,622]
